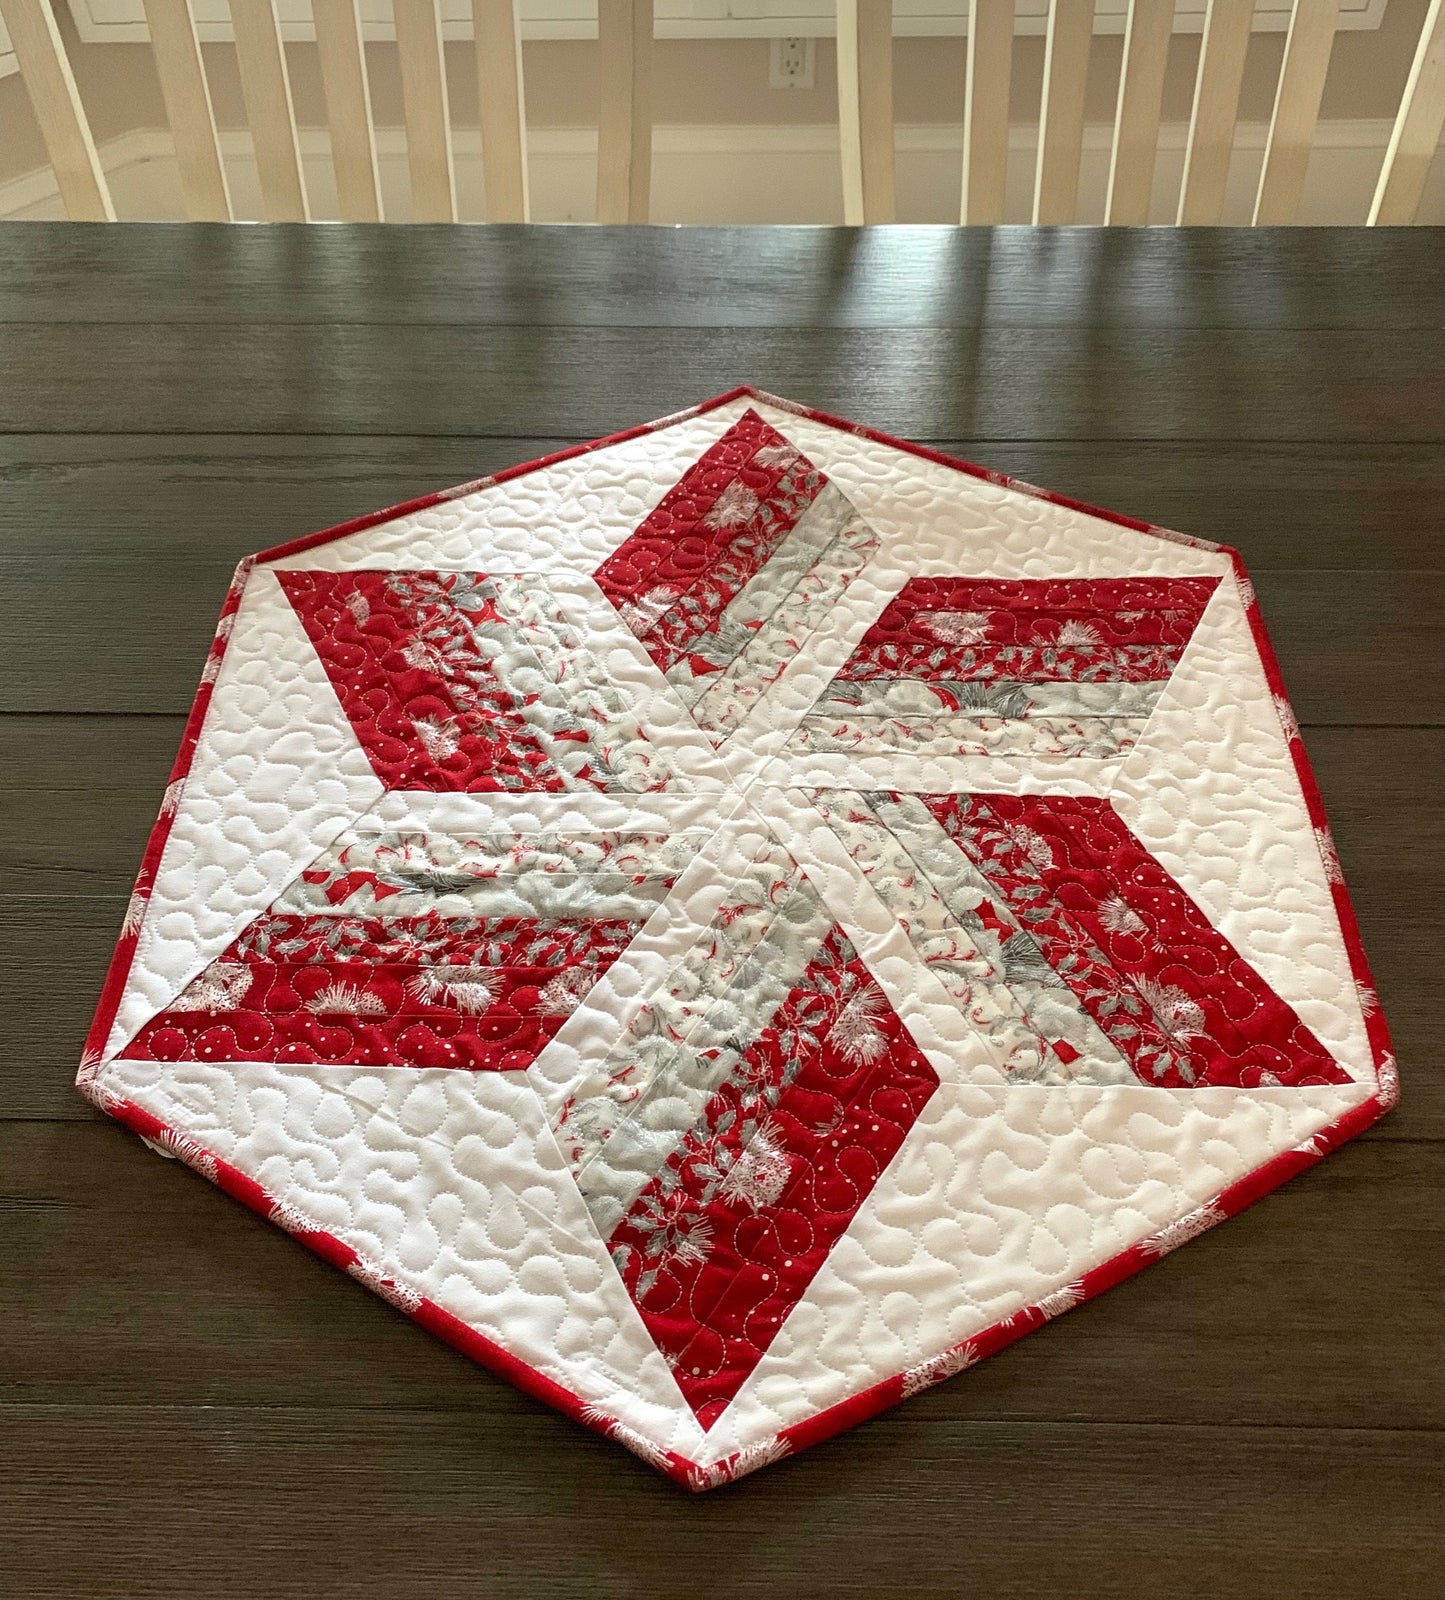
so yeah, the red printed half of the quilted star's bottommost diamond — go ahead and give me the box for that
[610,928,938,1427]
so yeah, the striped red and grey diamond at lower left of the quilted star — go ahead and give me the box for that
[125,834,693,1070]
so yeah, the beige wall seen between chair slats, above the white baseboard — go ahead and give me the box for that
[0,0,1429,181]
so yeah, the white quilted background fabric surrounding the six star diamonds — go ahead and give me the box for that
[83,395,1381,1486]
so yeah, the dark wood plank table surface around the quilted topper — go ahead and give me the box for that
[0,224,1445,1600]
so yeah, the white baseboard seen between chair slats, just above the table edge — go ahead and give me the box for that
[0,120,1445,224]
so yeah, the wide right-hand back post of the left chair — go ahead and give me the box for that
[597,0,653,222]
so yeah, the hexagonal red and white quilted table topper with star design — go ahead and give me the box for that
[78,390,1397,1488]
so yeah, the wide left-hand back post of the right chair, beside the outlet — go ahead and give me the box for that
[837,0,895,226]
